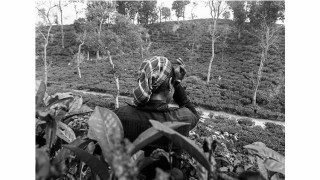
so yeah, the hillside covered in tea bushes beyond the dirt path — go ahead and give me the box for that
[36,19,285,121]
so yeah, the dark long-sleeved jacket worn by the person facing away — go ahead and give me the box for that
[115,84,199,154]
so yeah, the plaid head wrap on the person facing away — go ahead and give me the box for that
[133,56,172,106]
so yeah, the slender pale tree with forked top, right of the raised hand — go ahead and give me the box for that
[207,0,228,84]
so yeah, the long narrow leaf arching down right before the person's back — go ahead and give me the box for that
[150,120,211,172]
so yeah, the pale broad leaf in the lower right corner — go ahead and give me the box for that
[243,143,285,163]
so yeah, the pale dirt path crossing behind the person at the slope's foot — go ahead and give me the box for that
[69,89,285,127]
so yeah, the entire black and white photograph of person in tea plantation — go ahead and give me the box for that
[33,0,286,180]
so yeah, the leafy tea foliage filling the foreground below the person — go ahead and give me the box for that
[36,79,284,179]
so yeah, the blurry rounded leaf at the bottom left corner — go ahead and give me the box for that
[36,148,50,179]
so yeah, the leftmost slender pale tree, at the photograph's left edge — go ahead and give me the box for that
[36,1,57,85]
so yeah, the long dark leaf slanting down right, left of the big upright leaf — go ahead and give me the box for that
[63,145,110,180]
